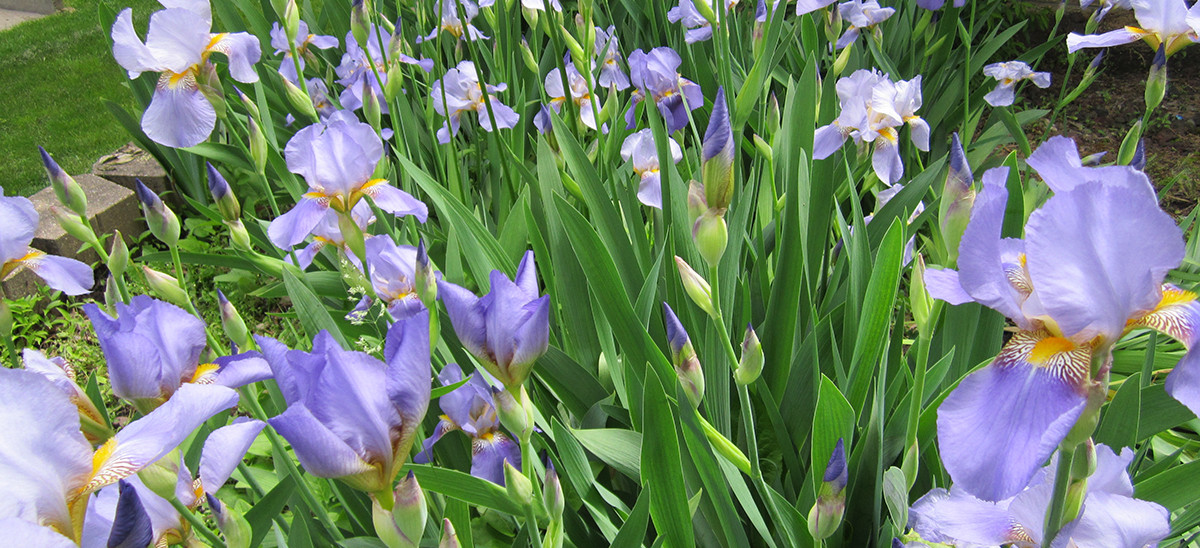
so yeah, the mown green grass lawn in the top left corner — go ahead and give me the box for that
[0,0,160,195]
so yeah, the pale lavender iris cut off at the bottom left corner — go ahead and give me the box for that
[0,369,238,546]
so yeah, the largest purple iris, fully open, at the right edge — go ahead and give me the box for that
[925,137,1200,501]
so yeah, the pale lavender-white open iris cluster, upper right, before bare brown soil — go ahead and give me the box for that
[812,70,929,186]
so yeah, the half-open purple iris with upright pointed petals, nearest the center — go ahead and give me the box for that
[438,252,550,391]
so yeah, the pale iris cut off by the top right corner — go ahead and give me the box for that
[1067,0,1200,55]
